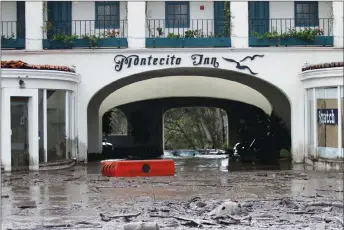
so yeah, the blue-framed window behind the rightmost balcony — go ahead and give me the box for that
[295,1,319,27]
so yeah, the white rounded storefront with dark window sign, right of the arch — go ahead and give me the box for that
[300,67,344,159]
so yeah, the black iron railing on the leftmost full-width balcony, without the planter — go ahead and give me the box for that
[43,20,128,39]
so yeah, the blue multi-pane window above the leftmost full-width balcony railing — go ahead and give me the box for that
[95,1,120,29]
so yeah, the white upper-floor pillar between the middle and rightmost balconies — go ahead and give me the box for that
[231,2,249,48]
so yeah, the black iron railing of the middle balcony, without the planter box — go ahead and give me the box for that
[146,19,230,38]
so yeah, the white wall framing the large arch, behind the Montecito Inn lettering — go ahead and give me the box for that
[2,47,343,162]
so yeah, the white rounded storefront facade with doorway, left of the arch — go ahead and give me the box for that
[1,69,79,171]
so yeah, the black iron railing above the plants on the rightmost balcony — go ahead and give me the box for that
[249,18,333,36]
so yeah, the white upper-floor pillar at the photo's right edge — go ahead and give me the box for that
[332,1,344,48]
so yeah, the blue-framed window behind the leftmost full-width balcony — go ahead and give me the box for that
[95,1,120,29]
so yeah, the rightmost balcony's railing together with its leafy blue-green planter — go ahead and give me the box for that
[249,18,333,46]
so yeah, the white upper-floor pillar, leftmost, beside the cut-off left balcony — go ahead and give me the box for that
[25,1,43,50]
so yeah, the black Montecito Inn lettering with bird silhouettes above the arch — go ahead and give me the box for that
[114,54,264,75]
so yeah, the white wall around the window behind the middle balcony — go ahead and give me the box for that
[146,1,214,37]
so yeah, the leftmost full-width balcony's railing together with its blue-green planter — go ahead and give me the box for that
[43,20,128,49]
